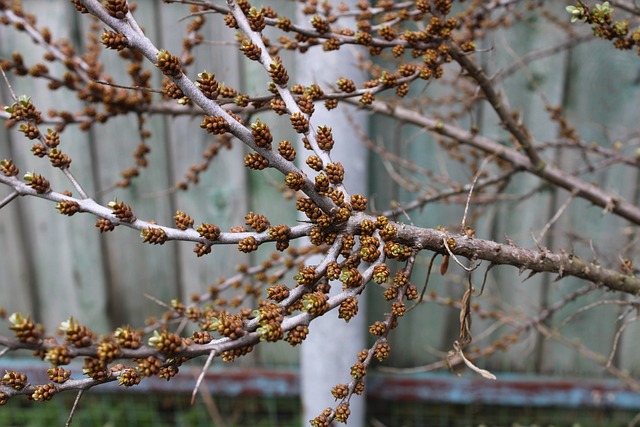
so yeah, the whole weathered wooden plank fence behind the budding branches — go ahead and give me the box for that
[0,1,640,382]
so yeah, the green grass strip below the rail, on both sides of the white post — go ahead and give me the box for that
[0,392,636,427]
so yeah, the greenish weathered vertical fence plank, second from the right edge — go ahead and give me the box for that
[477,6,576,371]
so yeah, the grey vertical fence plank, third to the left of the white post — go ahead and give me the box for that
[78,2,178,325]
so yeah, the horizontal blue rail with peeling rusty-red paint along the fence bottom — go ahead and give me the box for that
[0,358,640,410]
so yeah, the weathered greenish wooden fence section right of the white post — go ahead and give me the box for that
[370,4,639,382]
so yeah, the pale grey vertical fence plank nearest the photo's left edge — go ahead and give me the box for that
[0,1,107,328]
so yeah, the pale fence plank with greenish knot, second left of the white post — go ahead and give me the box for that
[160,5,249,322]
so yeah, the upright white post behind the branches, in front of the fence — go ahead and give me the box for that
[296,11,368,427]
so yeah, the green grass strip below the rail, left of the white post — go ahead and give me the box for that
[0,392,300,427]
